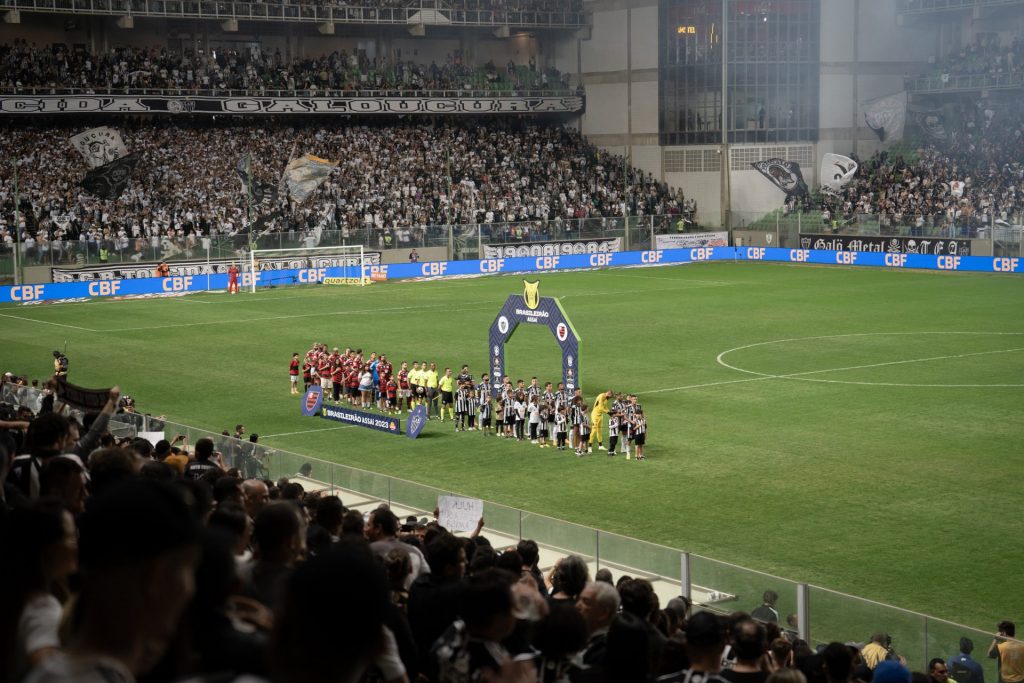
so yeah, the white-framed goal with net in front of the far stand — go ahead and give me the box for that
[242,245,377,292]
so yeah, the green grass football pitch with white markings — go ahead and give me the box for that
[0,263,1024,635]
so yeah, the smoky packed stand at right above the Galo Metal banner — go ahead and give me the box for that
[823,94,1024,237]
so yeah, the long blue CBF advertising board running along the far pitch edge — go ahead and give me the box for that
[0,244,1024,301]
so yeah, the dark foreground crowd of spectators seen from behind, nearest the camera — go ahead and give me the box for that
[0,368,1024,683]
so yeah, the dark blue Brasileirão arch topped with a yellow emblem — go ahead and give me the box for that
[487,280,583,392]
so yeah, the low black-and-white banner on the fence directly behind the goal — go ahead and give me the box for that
[51,252,381,283]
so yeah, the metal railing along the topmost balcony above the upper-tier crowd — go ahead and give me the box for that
[0,0,587,29]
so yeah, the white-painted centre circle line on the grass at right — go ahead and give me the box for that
[715,332,1024,388]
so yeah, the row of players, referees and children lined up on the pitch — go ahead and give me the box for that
[289,343,647,460]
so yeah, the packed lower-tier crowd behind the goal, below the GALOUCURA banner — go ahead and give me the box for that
[0,119,684,263]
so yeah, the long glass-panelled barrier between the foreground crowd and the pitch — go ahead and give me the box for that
[0,384,1011,663]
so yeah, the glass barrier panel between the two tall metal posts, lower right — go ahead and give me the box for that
[690,554,798,630]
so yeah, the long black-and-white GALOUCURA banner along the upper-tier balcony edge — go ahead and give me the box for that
[0,95,584,116]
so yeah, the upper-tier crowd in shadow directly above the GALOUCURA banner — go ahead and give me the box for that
[0,39,569,96]
